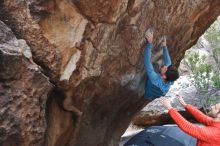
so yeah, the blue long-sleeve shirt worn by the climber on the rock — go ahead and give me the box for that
[144,43,173,100]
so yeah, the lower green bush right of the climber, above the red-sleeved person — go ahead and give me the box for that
[184,51,220,111]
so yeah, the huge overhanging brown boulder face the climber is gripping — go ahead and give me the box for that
[0,0,220,146]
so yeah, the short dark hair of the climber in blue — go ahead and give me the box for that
[165,65,179,81]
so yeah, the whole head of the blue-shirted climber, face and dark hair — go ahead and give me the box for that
[160,65,179,81]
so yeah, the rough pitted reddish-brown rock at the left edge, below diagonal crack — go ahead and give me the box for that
[0,21,52,146]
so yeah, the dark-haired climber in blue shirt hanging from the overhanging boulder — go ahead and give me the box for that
[144,29,179,101]
